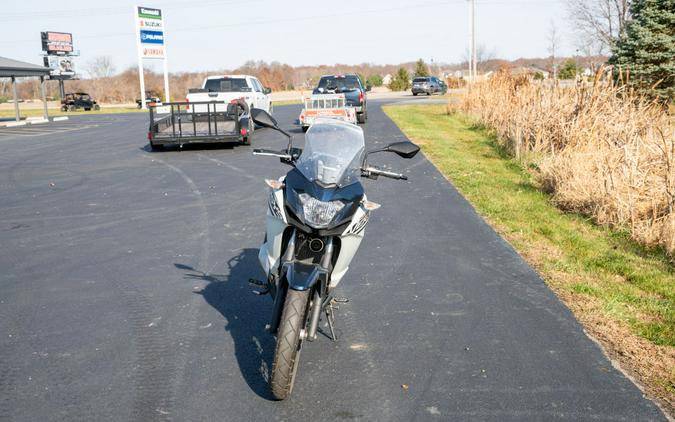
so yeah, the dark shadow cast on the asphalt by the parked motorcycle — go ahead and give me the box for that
[174,248,276,400]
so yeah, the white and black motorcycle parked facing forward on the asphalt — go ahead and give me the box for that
[249,109,419,400]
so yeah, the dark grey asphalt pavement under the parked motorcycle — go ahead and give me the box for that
[0,102,665,421]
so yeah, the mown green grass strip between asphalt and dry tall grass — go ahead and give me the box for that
[385,105,675,346]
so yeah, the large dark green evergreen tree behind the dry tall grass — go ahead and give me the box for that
[610,0,675,101]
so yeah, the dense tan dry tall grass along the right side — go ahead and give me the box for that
[449,71,675,256]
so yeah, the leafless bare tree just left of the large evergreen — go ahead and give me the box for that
[567,0,632,53]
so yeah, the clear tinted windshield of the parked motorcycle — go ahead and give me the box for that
[295,118,366,187]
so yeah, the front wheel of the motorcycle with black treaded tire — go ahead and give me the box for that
[270,289,309,400]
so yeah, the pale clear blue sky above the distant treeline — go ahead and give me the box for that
[0,0,575,75]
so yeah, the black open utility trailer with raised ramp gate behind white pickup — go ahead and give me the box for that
[148,100,253,151]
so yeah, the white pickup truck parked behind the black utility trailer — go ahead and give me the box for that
[185,75,272,114]
